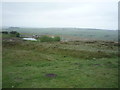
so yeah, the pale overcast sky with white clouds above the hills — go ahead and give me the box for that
[2,0,118,30]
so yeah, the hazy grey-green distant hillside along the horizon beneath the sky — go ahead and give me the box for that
[2,28,118,41]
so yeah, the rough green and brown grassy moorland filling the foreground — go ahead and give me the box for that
[2,34,118,88]
